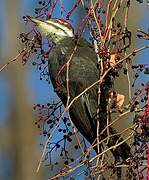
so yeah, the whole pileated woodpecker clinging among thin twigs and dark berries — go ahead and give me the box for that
[32,19,130,161]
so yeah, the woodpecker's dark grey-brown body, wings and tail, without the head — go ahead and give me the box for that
[49,38,130,159]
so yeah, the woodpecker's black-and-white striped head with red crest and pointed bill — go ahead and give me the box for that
[31,18,74,43]
